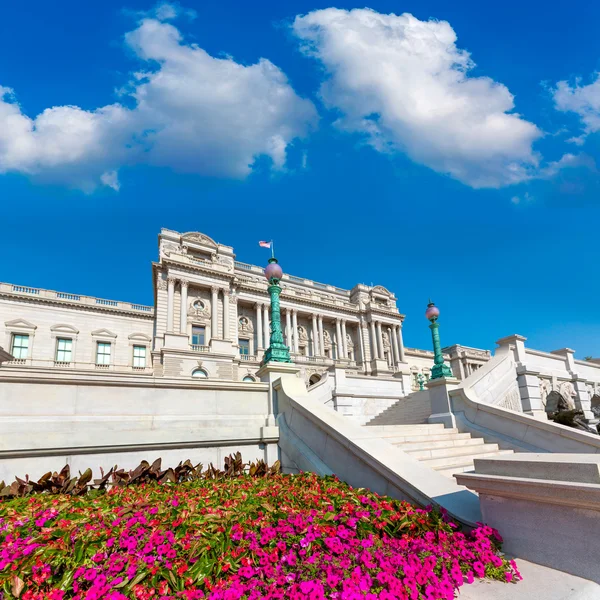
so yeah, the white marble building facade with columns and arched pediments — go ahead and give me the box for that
[0,229,489,391]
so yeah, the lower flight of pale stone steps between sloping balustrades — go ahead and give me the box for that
[364,422,513,477]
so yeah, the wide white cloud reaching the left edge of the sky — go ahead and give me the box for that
[0,14,316,191]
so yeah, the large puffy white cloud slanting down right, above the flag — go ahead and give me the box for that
[293,8,541,188]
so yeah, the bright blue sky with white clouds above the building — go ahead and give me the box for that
[0,0,600,357]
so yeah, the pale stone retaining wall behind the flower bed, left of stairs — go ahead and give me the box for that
[0,376,277,481]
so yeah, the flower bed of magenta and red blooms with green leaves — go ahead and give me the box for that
[0,464,520,600]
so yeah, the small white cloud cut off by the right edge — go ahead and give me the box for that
[552,73,600,139]
